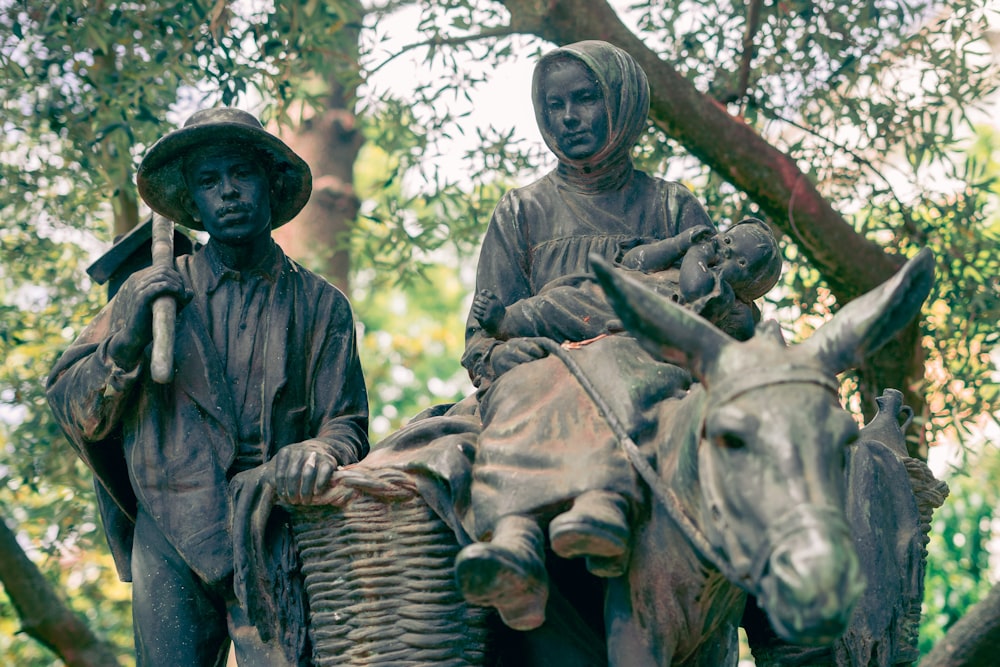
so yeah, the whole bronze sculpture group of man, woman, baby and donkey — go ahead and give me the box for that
[49,42,947,667]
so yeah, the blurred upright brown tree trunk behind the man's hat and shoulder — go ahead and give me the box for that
[274,0,363,291]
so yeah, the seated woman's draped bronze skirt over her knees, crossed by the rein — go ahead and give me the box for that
[465,335,691,539]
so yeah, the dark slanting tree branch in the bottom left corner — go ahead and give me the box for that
[0,512,120,667]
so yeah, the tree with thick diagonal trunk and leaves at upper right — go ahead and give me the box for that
[376,0,997,455]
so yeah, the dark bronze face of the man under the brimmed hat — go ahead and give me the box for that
[184,149,271,245]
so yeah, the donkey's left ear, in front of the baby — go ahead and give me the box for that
[590,254,732,376]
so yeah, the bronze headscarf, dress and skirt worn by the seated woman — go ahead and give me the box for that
[463,41,714,538]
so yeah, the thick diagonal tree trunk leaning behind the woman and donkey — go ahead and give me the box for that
[502,0,926,456]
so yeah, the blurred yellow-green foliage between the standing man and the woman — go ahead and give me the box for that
[350,101,492,441]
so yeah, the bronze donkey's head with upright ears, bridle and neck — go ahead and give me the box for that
[595,250,933,667]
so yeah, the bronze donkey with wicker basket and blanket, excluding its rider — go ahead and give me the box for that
[234,250,933,667]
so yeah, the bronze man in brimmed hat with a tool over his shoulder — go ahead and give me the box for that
[48,109,368,667]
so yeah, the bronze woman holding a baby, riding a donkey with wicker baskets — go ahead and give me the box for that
[197,42,941,667]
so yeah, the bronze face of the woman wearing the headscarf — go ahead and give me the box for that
[540,59,608,160]
